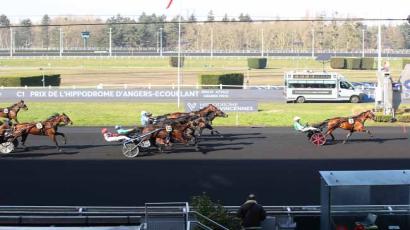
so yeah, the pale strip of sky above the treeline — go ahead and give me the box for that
[0,0,410,22]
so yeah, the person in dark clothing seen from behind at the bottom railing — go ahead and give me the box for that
[237,194,266,229]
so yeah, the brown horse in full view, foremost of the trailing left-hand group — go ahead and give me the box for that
[14,113,73,152]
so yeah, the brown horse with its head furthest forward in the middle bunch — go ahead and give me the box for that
[156,104,228,136]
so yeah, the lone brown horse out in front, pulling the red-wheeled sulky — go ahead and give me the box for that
[318,110,375,144]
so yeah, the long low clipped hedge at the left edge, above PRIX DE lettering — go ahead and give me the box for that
[0,74,61,87]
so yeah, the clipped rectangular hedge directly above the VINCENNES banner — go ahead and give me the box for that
[199,73,244,89]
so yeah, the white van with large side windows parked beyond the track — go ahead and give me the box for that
[284,71,365,103]
